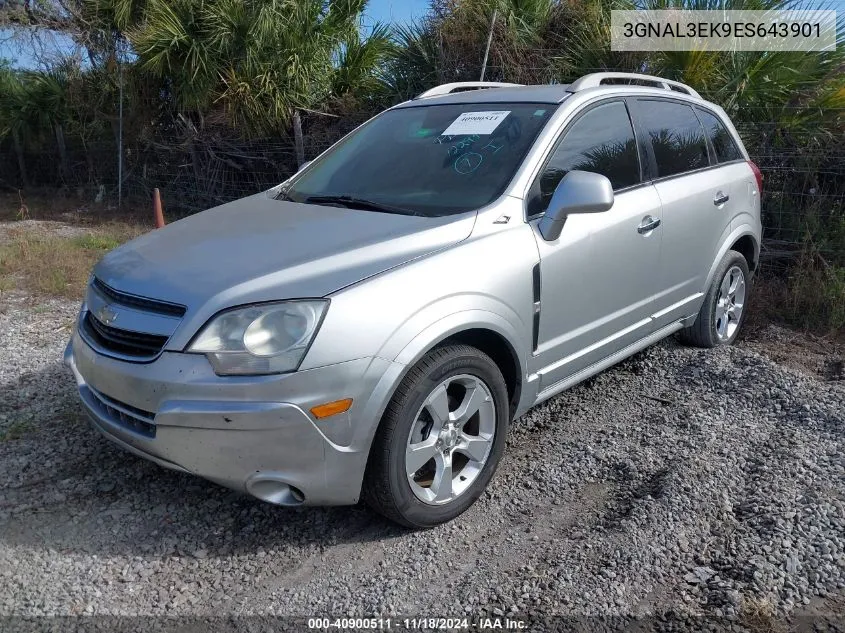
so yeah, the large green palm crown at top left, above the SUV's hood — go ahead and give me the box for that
[129,0,389,133]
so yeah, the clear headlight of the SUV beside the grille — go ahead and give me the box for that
[188,300,329,376]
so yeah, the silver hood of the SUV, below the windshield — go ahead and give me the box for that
[94,192,475,312]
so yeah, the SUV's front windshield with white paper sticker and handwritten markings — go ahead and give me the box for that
[280,103,557,216]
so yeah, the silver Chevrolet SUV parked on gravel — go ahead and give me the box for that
[65,73,761,527]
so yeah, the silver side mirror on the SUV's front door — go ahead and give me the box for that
[538,170,613,242]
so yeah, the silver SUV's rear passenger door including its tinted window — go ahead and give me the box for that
[634,98,734,326]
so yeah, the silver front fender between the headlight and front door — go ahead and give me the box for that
[302,224,537,369]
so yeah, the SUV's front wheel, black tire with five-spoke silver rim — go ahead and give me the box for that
[362,344,510,528]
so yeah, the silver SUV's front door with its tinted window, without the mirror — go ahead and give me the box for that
[529,100,662,391]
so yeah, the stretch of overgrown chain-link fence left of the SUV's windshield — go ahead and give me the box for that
[0,108,369,216]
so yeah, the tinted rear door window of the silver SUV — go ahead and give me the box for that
[637,99,710,178]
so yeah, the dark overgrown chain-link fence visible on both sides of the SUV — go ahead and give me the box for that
[0,112,845,261]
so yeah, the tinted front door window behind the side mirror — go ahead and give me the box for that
[529,101,640,209]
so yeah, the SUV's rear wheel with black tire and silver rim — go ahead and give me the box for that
[681,251,751,347]
